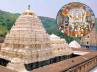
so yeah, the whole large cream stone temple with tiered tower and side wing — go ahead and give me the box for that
[0,6,72,72]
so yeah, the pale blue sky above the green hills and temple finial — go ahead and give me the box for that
[0,0,97,18]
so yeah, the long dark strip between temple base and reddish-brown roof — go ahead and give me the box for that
[25,54,79,71]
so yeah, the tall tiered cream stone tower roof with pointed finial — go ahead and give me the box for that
[1,6,49,47]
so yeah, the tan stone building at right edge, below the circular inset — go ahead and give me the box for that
[80,27,97,50]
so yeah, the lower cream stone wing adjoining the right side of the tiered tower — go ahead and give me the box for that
[50,34,72,56]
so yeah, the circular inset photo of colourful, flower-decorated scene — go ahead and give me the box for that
[57,2,95,37]
